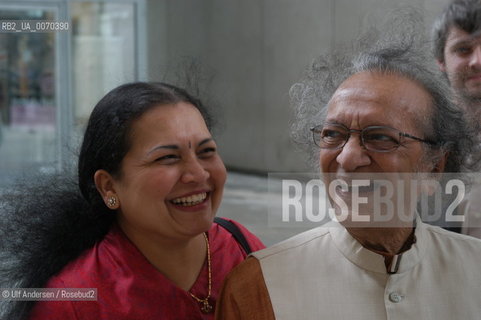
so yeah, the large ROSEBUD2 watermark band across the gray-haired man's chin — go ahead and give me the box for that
[268,173,475,227]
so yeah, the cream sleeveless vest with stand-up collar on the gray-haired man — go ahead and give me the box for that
[253,221,481,320]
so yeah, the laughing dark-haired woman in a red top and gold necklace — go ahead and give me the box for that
[0,83,263,319]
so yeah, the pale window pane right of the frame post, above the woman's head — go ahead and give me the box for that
[71,2,136,132]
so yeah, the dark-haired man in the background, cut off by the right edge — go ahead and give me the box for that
[433,0,481,238]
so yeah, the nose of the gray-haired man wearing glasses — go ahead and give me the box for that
[336,134,371,172]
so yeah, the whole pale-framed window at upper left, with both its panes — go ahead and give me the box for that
[0,0,142,187]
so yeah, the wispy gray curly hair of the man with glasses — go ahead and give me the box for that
[290,12,475,172]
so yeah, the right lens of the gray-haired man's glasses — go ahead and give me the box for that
[362,127,400,152]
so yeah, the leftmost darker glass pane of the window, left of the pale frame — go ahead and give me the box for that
[0,7,57,185]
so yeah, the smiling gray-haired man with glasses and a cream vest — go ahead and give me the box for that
[217,31,481,320]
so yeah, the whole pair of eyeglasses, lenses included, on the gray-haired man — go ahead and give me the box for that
[311,123,437,152]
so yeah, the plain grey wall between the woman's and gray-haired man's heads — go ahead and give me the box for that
[147,0,448,173]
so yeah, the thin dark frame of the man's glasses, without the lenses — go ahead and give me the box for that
[309,123,437,152]
